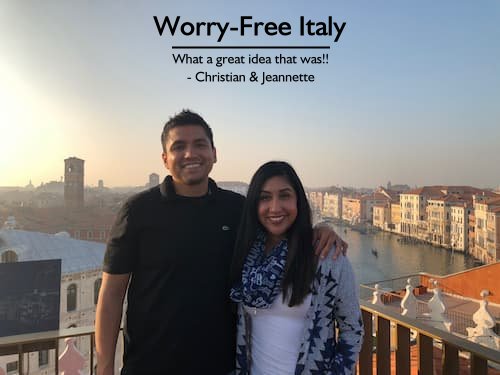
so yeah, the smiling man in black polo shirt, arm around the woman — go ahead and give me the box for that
[96,111,346,375]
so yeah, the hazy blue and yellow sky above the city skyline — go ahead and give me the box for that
[0,0,500,187]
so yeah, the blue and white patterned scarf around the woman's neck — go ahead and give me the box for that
[230,232,288,309]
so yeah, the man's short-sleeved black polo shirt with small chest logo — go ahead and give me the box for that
[103,176,244,375]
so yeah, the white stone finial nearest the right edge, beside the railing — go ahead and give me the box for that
[467,290,500,350]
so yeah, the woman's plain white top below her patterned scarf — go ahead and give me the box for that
[245,293,311,375]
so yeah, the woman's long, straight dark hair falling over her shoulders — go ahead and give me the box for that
[231,161,316,307]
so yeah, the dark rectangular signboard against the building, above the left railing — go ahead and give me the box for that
[0,259,61,337]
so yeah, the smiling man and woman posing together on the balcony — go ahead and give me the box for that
[96,111,362,375]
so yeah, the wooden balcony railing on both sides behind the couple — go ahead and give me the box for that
[0,301,500,375]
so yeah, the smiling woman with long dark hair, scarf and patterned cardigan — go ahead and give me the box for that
[231,161,363,375]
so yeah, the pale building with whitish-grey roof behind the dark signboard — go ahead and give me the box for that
[0,229,118,375]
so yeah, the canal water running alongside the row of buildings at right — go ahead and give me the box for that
[330,224,474,284]
